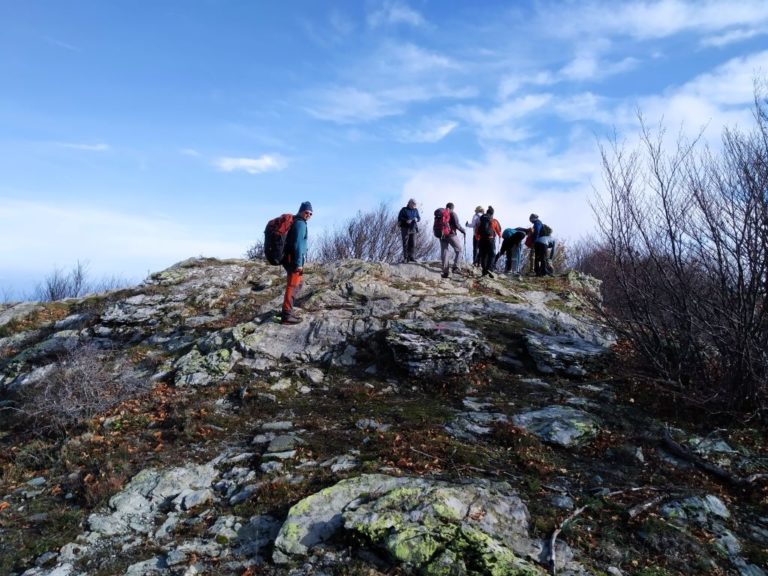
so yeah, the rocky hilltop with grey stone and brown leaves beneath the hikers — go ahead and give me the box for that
[0,258,768,576]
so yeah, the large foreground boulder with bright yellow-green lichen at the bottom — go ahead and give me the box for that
[273,474,560,576]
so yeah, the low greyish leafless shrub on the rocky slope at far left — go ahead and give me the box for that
[18,343,150,434]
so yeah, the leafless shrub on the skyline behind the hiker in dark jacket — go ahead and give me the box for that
[313,203,438,263]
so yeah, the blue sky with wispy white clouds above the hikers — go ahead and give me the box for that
[0,0,768,296]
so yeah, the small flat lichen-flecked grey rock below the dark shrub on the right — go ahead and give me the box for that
[512,406,599,448]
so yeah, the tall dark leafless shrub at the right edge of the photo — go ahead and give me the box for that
[582,88,768,411]
